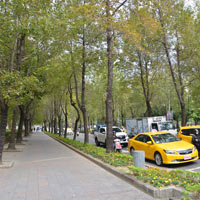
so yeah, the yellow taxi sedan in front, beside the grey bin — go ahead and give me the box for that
[128,132,199,166]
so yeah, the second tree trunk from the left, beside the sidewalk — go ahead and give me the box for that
[8,107,18,149]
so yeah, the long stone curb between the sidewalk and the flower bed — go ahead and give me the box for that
[45,133,183,200]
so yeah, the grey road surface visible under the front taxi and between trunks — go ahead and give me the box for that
[68,133,200,172]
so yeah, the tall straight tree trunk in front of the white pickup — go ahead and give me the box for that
[106,0,113,153]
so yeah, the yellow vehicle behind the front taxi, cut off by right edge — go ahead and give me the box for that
[178,125,200,143]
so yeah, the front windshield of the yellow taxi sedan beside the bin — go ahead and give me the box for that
[152,133,180,144]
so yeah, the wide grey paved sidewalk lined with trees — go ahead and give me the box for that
[0,133,153,200]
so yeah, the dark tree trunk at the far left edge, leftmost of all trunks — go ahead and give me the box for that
[0,102,8,164]
